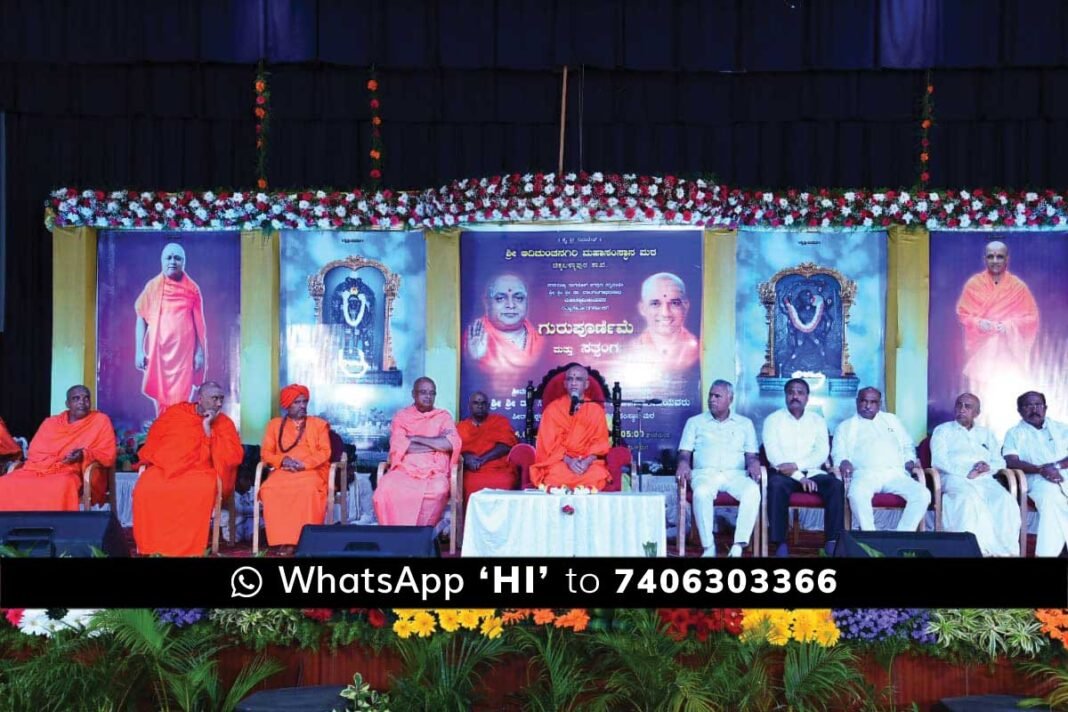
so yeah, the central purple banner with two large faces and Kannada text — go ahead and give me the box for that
[460,227,702,471]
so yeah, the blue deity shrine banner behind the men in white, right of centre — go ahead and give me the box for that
[734,231,886,433]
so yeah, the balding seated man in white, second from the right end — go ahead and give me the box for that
[931,393,1020,556]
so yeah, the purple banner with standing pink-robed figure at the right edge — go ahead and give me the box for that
[927,231,1068,438]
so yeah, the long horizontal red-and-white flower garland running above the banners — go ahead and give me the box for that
[46,172,1068,231]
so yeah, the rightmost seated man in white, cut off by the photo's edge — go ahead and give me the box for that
[1002,391,1068,556]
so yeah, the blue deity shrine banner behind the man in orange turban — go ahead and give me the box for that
[280,231,426,453]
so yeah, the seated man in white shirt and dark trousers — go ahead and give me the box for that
[764,378,846,556]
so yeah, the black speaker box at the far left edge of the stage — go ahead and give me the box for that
[0,511,129,557]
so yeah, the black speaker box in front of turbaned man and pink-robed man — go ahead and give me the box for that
[296,524,441,558]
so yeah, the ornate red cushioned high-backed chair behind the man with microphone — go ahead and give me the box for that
[508,362,634,492]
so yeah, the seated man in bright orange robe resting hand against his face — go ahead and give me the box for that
[134,381,245,556]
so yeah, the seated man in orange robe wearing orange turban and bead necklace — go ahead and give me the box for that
[260,383,330,554]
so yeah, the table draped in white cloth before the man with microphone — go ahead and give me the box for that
[460,490,668,556]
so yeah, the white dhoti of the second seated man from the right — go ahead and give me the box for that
[942,474,1020,556]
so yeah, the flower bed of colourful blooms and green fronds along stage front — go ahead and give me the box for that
[0,608,1068,710]
